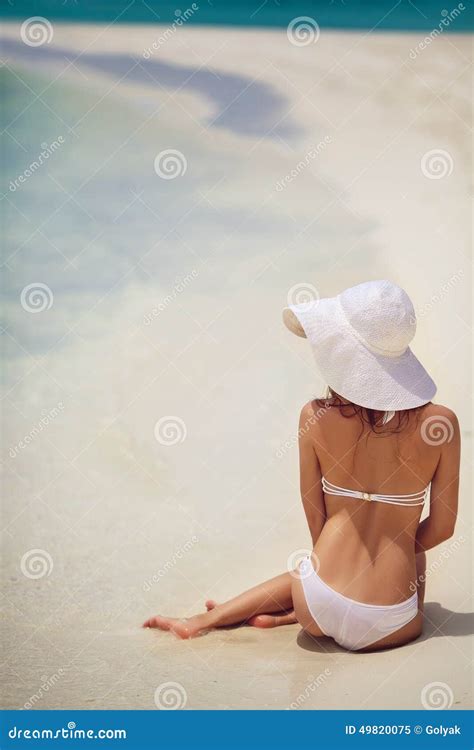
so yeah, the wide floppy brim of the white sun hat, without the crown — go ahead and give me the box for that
[283,297,436,411]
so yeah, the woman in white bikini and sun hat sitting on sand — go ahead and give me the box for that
[144,281,460,651]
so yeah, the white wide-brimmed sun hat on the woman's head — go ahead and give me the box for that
[283,281,436,411]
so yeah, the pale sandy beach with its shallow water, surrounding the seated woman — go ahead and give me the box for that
[2,23,473,710]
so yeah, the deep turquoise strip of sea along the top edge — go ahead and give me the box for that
[0,0,473,32]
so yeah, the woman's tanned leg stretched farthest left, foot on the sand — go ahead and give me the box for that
[143,573,293,638]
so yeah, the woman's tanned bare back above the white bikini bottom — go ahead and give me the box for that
[300,402,455,604]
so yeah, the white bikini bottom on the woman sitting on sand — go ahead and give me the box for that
[300,557,418,651]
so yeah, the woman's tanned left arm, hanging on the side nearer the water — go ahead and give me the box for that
[298,403,326,546]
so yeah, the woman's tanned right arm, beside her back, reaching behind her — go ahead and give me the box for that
[415,407,461,554]
